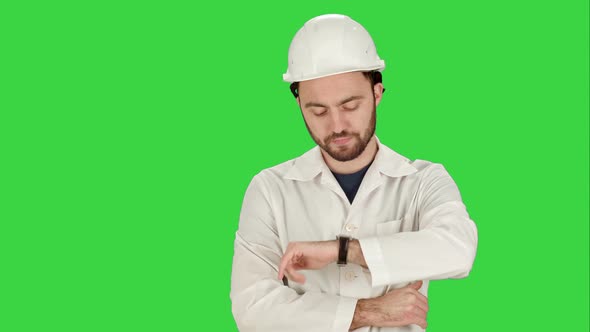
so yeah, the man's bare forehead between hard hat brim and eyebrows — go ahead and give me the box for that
[299,72,372,102]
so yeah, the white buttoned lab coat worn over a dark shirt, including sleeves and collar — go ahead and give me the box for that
[230,136,477,332]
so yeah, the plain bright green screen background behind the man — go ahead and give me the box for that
[0,0,589,332]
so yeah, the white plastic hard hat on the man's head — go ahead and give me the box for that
[283,14,385,83]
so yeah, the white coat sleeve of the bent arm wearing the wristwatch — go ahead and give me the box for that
[359,164,477,287]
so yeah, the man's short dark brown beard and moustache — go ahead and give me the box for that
[304,101,377,161]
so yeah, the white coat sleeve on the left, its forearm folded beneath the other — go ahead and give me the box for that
[230,174,357,332]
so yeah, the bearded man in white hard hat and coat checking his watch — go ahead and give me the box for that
[231,15,477,332]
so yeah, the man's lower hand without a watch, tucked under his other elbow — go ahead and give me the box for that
[350,281,428,330]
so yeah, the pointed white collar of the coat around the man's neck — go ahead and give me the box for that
[283,136,418,181]
